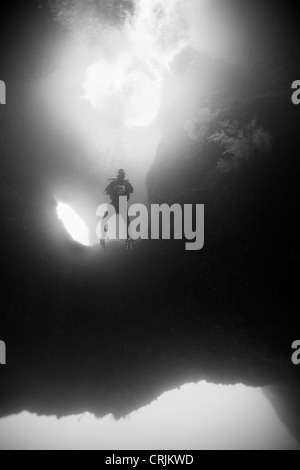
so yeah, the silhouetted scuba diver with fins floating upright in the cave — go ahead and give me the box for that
[101,169,134,251]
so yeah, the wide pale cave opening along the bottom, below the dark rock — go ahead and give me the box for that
[0,382,299,451]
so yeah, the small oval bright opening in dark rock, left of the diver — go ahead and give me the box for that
[57,202,90,246]
